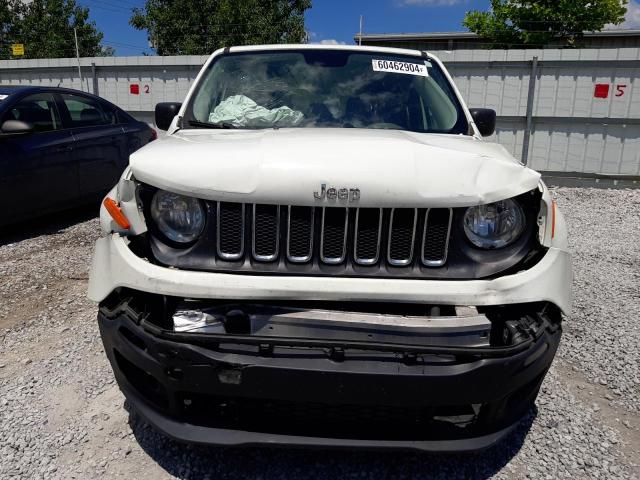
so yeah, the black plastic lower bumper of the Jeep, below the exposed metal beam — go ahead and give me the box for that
[98,294,560,452]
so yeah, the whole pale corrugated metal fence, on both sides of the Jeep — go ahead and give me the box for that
[0,48,640,176]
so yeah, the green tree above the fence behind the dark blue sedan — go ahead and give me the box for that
[0,0,113,59]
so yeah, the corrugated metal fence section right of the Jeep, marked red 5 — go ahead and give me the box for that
[440,48,640,175]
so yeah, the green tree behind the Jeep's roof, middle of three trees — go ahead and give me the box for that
[130,0,311,55]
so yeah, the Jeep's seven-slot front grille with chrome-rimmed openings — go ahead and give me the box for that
[212,202,453,268]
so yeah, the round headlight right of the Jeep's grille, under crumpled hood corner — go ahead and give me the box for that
[463,199,526,249]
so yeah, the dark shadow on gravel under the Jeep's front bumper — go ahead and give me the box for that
[125,403,537,480]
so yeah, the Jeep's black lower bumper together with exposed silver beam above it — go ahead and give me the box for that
[98,290,561,452]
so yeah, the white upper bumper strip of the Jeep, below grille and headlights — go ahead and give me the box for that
[89,234,573,314]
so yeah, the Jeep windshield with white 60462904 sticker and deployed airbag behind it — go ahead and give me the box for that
[184,50,468,134]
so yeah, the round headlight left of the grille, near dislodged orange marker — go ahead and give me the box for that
[151,190,206,244]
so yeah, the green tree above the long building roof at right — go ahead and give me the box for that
[462,0,627,47]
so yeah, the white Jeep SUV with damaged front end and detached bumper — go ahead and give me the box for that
[89,45,571,451]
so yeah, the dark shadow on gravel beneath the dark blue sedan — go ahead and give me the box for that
[0,203,100,246]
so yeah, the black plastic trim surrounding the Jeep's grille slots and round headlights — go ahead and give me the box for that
[140,185,546,280]
